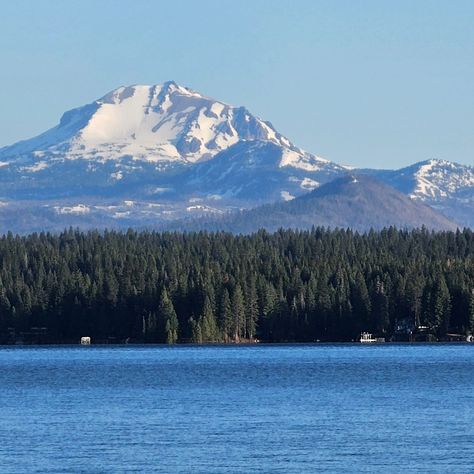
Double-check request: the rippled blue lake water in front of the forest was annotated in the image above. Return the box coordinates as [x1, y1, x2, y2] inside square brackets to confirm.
[0, 344, 474, 474]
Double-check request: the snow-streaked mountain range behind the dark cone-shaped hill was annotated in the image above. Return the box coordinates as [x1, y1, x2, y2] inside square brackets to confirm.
[0, 82, 474, 232]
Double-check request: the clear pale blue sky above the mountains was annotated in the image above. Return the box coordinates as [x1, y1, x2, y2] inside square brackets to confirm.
[0, 0, 474, 168]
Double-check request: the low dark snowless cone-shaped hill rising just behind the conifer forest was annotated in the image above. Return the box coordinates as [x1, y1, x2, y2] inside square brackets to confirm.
[170, 174, 457, 233]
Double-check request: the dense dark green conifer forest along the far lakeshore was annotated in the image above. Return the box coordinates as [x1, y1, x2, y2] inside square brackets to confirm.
[0, 228, 474, 343]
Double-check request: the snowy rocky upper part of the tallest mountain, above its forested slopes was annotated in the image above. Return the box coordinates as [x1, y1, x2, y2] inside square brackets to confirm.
[0, 81, 320, 171]
